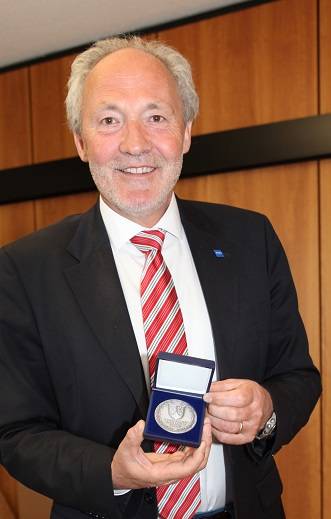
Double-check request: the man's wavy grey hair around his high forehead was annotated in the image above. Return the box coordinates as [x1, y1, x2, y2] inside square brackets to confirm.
[65, 36, 199, 134]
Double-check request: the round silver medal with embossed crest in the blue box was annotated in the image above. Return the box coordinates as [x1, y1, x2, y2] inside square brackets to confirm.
[154, 399, 197, 434]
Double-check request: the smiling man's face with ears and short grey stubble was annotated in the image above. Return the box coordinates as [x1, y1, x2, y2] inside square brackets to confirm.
[75, 49, 191, 227]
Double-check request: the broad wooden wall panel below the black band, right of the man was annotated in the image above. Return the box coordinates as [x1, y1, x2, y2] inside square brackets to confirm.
[176, 163, 321, 519]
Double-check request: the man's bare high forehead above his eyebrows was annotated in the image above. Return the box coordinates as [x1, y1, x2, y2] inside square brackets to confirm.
[84, 49, 181, 109]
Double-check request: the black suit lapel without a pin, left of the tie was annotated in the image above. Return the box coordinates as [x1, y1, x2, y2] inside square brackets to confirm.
[65, 206, 148, 417]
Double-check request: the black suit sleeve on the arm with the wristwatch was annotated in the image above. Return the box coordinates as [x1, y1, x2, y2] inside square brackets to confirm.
[256, 220, 321, 453]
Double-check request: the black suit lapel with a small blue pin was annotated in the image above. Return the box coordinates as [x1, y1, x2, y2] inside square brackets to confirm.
[178, 201, 238, 379]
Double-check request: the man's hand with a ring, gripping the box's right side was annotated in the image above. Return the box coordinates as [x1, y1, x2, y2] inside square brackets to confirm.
[204, 379, 273, 445]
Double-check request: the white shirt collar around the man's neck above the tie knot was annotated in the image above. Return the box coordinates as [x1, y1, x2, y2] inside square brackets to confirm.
[99, 194, 184, 249]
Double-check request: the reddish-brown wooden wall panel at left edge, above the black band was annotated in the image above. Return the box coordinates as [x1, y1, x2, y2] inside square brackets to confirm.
[0, 68, 31, 169]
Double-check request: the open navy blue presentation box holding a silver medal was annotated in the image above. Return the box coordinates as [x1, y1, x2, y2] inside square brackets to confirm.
[144, 352, 215, 447]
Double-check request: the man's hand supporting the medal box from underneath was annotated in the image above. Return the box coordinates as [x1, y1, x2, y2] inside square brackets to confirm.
[111, 418, 212, 489]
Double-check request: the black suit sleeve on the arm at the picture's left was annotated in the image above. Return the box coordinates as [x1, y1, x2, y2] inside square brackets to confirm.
[0, 250, 121, 518]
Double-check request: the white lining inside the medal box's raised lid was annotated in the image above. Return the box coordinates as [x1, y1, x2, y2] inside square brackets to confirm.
[155, 359, 212, 395]
